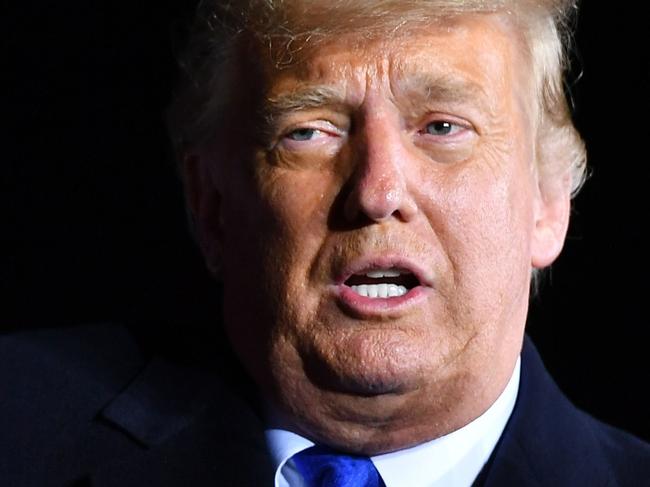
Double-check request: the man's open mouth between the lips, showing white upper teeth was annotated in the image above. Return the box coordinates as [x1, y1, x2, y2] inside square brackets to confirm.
[344, 267, 420, 299]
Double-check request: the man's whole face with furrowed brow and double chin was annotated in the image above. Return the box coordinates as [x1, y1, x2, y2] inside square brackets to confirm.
[195, 15, 565, 453]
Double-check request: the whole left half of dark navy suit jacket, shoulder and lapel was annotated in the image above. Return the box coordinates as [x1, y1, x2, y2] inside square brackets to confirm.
[0, 325, 274, 487]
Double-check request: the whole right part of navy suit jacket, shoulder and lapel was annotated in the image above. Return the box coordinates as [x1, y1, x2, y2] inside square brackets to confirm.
[476, 340, 650, 487]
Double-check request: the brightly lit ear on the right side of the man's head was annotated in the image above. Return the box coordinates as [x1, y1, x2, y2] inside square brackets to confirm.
[531, 173, 571, 269]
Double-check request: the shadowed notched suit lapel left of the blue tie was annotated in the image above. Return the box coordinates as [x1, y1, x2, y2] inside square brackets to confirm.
[91, 359, 273, 487]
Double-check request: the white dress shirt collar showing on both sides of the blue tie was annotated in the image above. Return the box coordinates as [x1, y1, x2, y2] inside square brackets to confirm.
[266, 359, 521, 487]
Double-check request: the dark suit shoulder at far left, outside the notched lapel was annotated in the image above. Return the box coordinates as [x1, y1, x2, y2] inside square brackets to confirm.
[0, 325, 144, 485]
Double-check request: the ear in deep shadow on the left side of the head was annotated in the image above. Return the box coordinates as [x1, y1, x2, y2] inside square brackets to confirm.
[182, 152, 223, 275]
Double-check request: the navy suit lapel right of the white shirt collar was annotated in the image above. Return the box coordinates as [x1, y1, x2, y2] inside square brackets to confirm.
[475, 337, 615, 487]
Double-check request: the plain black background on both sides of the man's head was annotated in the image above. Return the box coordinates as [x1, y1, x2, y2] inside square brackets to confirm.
[0, 0, 650, 440]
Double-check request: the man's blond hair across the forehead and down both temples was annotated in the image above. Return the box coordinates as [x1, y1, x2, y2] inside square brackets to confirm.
[169, 0, 586, 195]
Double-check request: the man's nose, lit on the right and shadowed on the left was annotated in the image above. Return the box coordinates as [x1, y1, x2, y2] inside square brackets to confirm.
[344, 114, 418, 223]
